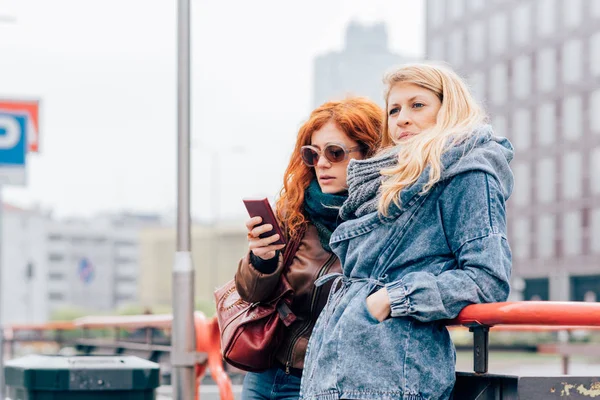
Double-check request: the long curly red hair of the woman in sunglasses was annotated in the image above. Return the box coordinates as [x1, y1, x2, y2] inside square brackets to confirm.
[275, 97, 385, 238]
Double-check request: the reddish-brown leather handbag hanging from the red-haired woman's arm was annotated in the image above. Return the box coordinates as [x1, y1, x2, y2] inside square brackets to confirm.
[214, 225, 304, 372]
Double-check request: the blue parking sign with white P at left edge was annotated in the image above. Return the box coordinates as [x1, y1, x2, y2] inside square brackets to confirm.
[0, 111, 29, 185]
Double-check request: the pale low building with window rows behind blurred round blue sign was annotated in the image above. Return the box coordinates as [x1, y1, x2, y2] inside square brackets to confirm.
[46, 216, 138, 313]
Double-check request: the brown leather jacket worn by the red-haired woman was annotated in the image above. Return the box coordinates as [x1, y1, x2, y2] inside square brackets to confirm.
[235, 224, 342, 372]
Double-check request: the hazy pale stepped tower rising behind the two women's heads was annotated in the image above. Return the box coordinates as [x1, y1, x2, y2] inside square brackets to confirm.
[313, 22, 407, 107]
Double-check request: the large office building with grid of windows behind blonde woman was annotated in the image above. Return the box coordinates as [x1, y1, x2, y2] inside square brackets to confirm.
[426, 0, 600, 300]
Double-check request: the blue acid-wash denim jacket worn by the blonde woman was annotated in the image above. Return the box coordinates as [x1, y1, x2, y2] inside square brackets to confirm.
[301, 126, 513, 400]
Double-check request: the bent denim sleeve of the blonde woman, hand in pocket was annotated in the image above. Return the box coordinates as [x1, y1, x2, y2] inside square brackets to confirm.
[386, 171, 512, 322]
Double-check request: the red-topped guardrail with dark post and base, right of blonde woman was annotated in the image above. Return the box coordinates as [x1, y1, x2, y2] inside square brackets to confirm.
[448, 301, 600, 400]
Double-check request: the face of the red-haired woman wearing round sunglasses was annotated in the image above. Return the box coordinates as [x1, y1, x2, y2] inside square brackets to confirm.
[310, 121, 363, 193]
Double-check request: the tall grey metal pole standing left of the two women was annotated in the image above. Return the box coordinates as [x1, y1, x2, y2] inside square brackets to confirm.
[171, 0, 196, 400]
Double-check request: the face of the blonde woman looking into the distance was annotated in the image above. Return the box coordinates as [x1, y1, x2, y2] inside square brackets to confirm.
[387, 83, 442, 143]
